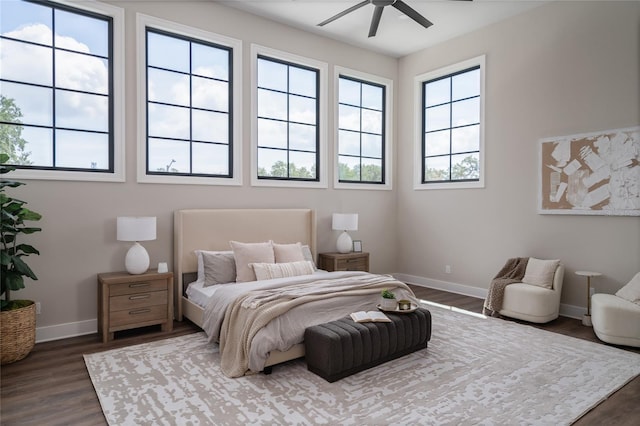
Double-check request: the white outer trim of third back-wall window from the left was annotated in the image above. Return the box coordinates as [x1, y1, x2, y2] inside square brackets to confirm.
[251, 44, 328, 188]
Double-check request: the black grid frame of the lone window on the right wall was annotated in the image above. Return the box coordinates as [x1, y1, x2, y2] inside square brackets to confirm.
[420, 65, 484, 185]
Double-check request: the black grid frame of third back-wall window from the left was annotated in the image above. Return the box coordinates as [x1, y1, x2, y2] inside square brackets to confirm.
[255, 54, 321, 182]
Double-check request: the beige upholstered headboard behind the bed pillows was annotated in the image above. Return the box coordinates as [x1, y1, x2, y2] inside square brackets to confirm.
[173, 209, 316, 320]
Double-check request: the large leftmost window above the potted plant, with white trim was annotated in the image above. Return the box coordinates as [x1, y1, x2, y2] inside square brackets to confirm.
[0, 1, 124, 180]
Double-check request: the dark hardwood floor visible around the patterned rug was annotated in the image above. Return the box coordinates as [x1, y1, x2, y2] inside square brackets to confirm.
[0, 286, 640, 426]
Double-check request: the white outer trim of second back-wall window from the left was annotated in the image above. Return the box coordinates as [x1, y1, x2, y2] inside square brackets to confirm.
[136, 13, 242, 186]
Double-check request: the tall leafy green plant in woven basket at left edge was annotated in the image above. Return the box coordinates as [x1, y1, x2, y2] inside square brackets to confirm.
[0, 153, 42, 364]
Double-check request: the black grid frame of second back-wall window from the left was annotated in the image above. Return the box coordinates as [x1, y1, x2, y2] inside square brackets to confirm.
[144, 26, 235, 179]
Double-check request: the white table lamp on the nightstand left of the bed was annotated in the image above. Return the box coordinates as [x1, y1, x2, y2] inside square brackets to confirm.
[117, 216, 156, 275]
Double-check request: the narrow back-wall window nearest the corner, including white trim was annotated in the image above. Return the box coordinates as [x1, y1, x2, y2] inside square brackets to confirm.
[335, 67, 392, 189]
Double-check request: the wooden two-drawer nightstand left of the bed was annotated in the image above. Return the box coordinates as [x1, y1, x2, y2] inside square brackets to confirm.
[98, 270, 173, 343]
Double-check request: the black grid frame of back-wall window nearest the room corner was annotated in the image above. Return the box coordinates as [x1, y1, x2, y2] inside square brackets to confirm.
[336, 74, 387, 185]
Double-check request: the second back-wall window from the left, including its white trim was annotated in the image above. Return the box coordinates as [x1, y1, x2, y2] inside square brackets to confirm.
[138, 15, 241, 184]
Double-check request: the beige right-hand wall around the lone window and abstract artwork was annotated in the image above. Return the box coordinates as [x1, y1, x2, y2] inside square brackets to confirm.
[397, 2, 640, 307]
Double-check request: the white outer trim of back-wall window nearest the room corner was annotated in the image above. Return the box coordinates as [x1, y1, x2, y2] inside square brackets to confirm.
[333, 66, 394, 190]
